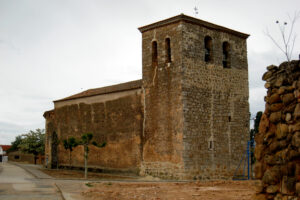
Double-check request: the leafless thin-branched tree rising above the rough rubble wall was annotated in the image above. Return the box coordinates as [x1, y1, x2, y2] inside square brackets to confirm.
[266, 11, 300, 62]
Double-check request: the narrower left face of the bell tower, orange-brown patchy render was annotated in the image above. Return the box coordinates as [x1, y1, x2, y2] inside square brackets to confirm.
[141, 23, 183, 179]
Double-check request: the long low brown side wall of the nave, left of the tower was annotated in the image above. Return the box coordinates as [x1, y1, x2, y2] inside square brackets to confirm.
[46, 91, 143, 173]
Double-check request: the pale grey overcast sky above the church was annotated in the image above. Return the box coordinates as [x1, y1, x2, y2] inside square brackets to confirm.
[0, 0, 300, 144]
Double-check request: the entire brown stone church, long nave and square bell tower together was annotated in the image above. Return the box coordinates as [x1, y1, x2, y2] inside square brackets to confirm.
[44, 14, 249, 179]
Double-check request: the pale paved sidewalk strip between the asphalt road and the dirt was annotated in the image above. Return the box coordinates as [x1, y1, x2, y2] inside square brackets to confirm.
[10, 162, 87, 200]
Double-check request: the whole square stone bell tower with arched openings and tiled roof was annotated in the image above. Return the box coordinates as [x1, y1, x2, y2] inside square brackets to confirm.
[139, 14, 249, 179]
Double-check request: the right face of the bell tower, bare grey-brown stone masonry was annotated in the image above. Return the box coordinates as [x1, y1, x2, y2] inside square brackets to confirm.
[182, 23, 249, 179]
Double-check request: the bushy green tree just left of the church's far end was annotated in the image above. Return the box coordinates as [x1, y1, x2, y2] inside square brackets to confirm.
[15, 129, 45, 156]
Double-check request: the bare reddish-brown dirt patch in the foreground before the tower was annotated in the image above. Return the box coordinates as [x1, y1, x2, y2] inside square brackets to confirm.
[82, 181, 255, 200]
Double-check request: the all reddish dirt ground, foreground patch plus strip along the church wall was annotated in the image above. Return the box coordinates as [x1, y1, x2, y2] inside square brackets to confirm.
[42, 169, 255, 200]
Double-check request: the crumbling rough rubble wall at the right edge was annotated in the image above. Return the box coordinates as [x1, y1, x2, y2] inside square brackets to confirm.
[255, 61, 300, 200]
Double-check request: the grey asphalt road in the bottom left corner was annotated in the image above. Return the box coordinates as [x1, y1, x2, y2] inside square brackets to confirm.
[0, 163, 62, 200]
